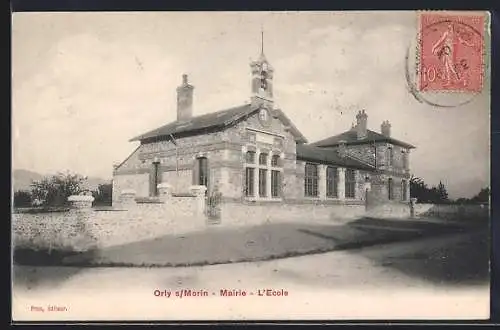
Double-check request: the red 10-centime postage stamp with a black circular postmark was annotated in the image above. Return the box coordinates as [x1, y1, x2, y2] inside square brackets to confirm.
[418, 12, 484, 93]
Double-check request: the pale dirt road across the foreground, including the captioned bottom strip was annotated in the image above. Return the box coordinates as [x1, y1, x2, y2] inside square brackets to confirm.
[13, 228, 489, 320]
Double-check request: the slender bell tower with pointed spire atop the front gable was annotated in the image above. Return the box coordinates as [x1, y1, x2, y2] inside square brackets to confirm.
[250, 31, 274, 108]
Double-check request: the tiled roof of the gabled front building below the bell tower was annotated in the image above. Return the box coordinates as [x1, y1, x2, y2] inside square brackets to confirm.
[130, 104, 307, 143]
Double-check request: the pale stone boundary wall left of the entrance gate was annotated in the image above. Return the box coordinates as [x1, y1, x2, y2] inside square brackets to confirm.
[12, 189, 206, 251]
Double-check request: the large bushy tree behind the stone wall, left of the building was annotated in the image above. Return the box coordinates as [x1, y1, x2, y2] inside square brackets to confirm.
[31, 172, 86, 206]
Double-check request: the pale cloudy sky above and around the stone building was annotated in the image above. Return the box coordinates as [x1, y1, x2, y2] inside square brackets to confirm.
[12, 12, 490, 198]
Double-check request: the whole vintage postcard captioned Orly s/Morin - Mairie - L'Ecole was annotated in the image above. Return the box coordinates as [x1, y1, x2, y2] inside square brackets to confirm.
[11, 11, 490, 322]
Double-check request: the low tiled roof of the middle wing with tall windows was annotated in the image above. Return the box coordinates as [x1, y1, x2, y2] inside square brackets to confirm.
[297, 144, 375, 170]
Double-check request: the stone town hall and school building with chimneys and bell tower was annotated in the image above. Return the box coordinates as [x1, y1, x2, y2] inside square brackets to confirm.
[113, 46, 414, 220]
